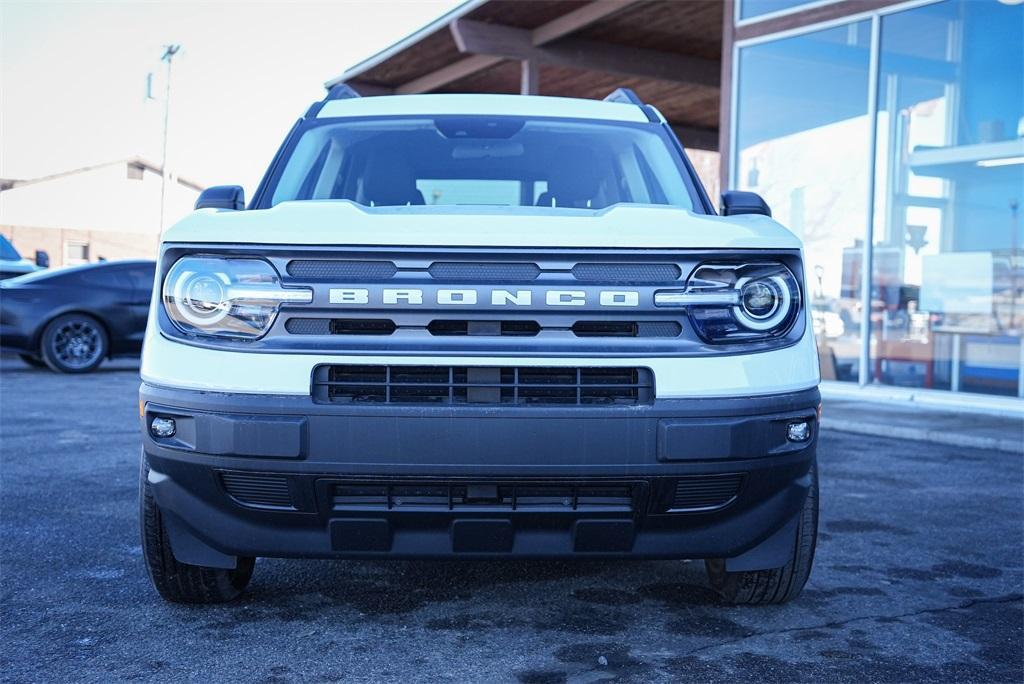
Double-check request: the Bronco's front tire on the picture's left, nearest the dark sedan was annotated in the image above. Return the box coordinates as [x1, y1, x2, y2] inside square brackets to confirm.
[138, 454, 256, 603]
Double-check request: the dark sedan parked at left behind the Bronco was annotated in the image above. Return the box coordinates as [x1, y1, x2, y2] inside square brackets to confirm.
[0, 261, 156, 373]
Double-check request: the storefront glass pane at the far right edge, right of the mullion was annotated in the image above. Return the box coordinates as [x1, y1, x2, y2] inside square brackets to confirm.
[870, 0, 1024, 396]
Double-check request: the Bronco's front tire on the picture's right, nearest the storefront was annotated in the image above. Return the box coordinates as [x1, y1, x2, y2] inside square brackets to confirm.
[705, 464, 818, 605]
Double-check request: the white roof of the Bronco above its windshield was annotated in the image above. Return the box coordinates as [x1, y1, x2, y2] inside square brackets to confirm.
[316, 94, 648, 123]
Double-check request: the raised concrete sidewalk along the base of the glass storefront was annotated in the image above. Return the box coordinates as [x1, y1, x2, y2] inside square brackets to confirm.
[821, 398, 1024, 455]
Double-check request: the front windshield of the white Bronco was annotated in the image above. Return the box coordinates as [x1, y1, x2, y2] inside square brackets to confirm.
[262, 116, 695, 209]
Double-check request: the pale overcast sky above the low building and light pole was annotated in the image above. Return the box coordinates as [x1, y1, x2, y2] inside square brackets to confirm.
[0, 0, 461, 198]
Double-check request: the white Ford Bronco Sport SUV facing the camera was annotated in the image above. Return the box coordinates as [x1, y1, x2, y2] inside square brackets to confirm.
[139, 86, 819, 603]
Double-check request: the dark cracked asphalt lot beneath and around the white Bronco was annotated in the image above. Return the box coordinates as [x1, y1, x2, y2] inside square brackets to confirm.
[0, 357, 1024, 683]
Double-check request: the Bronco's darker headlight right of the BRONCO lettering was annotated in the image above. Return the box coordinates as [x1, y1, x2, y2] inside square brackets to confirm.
[654, 262, 800, 342]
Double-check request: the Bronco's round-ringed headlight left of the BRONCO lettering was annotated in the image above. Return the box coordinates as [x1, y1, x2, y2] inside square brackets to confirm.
[164, 257, 313, 340]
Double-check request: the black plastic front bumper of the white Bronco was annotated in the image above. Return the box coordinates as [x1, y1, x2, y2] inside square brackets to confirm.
[141, 384, 819, 569]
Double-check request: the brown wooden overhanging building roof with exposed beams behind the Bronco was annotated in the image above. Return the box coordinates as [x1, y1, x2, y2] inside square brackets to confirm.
[327, 0, 720, 149]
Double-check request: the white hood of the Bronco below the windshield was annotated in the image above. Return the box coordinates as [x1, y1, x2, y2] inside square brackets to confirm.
[164, 201, 801, 249]
